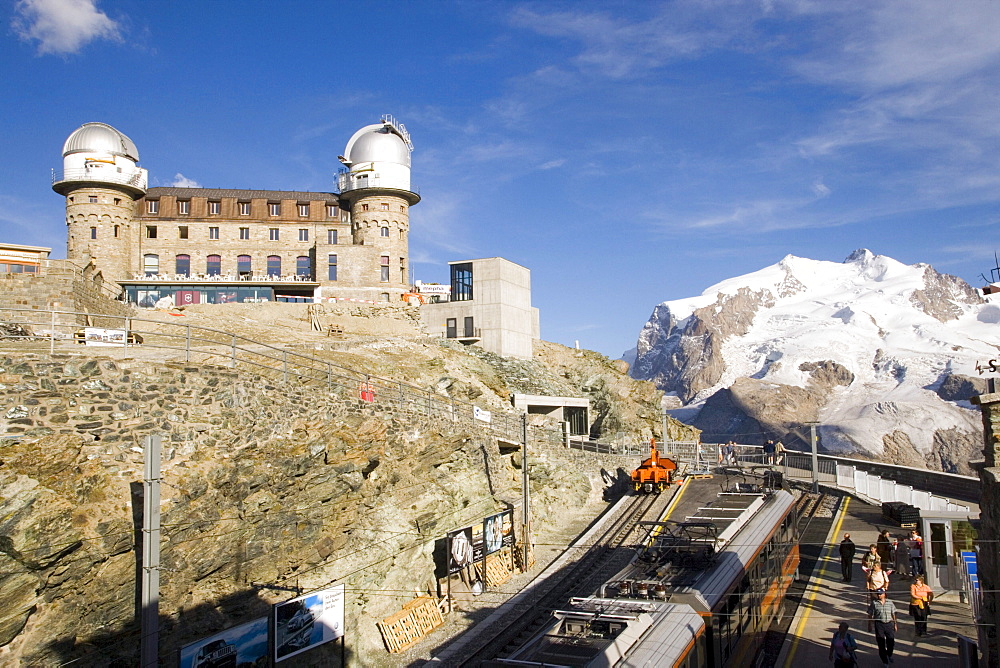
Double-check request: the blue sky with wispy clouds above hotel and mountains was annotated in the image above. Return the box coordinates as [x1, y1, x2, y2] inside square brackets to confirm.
[0, 0, 1000, 357]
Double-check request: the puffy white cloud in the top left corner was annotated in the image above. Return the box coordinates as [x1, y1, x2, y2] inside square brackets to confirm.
[12, 0, 121, 54]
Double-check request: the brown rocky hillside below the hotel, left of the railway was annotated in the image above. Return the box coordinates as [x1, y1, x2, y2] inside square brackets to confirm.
[0, 305, 690, 666]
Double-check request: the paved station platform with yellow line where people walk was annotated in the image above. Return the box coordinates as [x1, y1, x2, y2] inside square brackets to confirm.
[775, 497, 976, 668]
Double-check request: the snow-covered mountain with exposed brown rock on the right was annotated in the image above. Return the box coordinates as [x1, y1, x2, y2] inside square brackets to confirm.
[630, 250, 1000, 472]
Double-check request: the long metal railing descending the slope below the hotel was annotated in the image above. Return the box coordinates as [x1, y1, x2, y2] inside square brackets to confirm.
[0, 308, 521, 443]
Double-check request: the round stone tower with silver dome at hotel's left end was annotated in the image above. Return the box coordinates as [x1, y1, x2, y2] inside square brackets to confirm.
[52, 123, 147, 281]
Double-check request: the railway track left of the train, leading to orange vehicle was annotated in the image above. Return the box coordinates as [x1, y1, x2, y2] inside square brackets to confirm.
[445, 494, 673, 668]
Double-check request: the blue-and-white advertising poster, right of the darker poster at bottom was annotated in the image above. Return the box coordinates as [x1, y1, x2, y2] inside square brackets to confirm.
[274, 585, 344, 662]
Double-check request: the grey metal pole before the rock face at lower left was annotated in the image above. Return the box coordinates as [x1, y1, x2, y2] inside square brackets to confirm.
[139, 434, 161, 668]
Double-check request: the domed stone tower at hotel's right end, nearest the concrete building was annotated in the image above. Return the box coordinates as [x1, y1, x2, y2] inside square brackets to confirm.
[338, 116, 420, 301]
